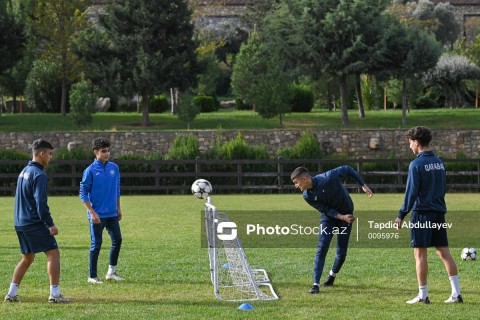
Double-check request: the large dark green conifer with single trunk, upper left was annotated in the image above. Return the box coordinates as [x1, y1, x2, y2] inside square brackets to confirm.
[77, 0, 197, 127]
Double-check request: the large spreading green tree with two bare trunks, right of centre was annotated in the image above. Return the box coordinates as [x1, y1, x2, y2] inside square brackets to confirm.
[265, 0, 394, 125]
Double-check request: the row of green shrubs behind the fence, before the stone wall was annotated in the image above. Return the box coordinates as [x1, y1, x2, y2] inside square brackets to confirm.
[0, 132, 477, 192]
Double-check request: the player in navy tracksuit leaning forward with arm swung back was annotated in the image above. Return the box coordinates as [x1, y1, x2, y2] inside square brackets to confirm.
[290, 165, 373, 293]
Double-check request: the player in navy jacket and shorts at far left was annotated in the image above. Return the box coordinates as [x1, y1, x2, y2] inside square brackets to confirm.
[4, 139, 69, 303]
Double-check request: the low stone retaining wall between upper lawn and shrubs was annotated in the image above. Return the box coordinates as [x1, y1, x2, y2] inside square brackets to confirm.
[0, 129, 480, 158]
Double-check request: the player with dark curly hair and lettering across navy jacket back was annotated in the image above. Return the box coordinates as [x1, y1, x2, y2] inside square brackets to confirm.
[395, 126, 463, 304]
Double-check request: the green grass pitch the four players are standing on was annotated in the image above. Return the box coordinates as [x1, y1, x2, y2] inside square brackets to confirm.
[0, 194, 480, 319]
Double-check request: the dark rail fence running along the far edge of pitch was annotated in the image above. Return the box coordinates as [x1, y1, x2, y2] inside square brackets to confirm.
[0, 158, 480, 195]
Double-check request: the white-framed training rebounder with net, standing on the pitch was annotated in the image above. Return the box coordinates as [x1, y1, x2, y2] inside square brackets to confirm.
[205, 197, 278, 301]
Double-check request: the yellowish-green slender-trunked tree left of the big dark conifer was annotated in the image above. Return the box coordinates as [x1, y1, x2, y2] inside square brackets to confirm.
[29, 0, 90, 116]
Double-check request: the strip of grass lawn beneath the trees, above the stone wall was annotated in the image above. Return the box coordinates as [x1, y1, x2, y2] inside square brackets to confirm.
[0, 108, 480, 132]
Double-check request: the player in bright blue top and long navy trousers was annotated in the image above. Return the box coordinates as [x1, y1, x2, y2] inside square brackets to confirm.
[80, 138, 123, 284]
